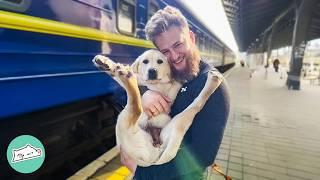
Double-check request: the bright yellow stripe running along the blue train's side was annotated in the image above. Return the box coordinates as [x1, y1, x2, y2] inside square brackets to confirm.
[0, 10, 154, 48]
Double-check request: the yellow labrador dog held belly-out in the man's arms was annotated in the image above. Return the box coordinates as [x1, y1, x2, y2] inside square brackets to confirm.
[93, 50, 222, 166]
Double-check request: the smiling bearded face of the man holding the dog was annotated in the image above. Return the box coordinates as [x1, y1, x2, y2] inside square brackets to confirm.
[155, 26, 200, 80]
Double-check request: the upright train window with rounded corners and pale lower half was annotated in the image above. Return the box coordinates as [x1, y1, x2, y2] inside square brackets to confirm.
[117, 0, 136, 35]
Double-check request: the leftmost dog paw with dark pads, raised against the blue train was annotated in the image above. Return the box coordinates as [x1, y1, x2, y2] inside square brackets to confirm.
[92, 55, 115, 76]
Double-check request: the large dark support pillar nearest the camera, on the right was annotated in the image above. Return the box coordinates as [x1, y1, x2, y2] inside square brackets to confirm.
[286, 0, 317, 90]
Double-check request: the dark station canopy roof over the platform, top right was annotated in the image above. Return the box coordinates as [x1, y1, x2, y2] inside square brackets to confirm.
[222, 0, 320, 52]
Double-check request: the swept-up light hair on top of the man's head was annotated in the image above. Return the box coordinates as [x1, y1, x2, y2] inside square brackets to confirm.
[145, 6, 189, 43]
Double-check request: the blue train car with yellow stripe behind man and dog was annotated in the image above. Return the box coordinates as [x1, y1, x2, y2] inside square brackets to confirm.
[0, 0, 235, 179]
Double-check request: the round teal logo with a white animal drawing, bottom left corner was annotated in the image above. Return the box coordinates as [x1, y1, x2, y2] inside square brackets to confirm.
[7, 135, 45, 174]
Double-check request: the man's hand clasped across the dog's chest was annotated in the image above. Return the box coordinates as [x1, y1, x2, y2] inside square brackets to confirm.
[142, 90, 172, 117]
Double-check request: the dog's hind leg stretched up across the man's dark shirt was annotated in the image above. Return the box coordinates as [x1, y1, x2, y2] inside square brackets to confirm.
[156, 71, 223, 164]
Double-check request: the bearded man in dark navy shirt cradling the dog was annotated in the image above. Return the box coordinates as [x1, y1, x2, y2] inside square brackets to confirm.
[121, 6, 229, 180]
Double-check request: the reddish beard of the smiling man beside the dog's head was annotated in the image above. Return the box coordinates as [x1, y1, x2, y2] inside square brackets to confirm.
[170, 49, 200, 83]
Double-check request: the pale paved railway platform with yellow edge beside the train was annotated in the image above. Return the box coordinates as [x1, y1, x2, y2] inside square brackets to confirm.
[70, 67, 320, 180]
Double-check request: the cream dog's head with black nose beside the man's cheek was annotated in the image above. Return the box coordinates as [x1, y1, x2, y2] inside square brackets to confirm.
[131, 49, 171, 85]
